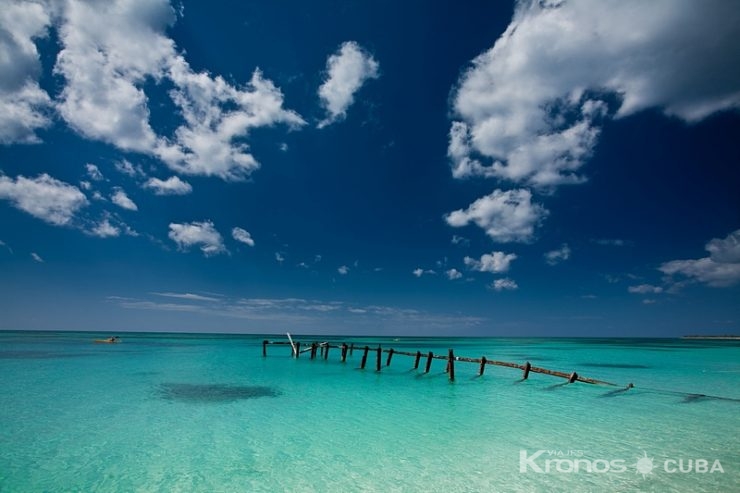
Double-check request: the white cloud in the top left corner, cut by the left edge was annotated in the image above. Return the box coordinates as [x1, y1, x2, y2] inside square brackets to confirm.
[0, 1, 52, 144]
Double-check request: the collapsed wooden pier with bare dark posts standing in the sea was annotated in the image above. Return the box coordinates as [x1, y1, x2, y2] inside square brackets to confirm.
[262, 335, 617, 386]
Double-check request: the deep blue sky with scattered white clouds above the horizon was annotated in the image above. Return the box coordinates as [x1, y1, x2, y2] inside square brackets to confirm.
[0, 0, 740, 336]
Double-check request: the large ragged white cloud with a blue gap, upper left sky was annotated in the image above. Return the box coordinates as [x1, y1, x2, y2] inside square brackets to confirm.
[49, 0, 305, 180]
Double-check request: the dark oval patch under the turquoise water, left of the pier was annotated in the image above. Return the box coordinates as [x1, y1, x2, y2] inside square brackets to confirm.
[159, 383, 280, 403]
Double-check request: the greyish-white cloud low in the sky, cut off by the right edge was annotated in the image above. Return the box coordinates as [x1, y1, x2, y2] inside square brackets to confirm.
[659, 229, 740, 288]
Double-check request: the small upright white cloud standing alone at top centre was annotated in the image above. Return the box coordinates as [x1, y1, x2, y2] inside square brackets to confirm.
[318, 41, 379, 128]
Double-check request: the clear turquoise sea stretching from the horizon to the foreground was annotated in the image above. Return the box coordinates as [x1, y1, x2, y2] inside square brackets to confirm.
[0, 332, 740, 493]
